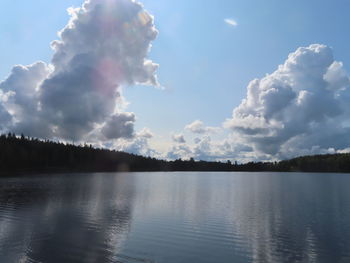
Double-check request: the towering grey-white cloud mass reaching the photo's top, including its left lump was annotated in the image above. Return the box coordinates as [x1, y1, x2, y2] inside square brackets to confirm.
[0, 0, 158, 140]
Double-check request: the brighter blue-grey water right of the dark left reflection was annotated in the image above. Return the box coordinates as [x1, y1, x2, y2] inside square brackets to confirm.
[126, 173, 350, 263]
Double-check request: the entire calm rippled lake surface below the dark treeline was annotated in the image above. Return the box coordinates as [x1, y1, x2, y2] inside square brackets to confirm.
[0, 173, 350, 263]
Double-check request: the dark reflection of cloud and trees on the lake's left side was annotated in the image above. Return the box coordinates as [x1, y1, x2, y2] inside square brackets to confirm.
[0, 175, 134, 263]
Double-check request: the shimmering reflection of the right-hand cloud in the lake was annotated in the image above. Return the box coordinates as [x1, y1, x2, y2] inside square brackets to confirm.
[228, 174, 350, 262]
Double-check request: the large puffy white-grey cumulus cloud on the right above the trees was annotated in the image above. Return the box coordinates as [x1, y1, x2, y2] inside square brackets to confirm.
[225, 44, 350, 158]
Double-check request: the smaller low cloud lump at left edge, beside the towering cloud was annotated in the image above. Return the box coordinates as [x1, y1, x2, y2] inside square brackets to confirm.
[0, 62, 51, 138]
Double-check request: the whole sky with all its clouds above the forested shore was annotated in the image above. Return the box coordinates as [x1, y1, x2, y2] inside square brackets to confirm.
[0, 0, 350, 162]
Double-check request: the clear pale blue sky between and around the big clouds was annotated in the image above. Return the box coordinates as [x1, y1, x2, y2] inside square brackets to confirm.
[0, 0, 350, 162]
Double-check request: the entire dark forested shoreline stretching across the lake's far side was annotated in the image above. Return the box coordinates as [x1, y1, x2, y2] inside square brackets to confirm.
[0, 133, 350, 175]
